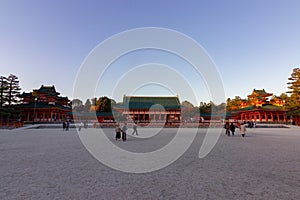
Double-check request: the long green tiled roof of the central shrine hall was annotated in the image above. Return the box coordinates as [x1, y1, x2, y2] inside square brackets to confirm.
[121, 96, 180, 109]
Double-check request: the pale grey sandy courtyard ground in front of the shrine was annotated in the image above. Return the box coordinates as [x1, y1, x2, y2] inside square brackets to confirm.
[0, 128, 300, 200]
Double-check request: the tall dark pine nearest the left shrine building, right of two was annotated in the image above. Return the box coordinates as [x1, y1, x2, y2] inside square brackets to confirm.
[7, 74, 21, 109]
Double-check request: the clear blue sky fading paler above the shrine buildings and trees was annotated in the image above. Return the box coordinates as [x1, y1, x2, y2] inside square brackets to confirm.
[0, 0, 300, 105]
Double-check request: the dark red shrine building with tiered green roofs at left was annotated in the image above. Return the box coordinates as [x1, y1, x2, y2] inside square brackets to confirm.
[18, 85, 72, 122]
